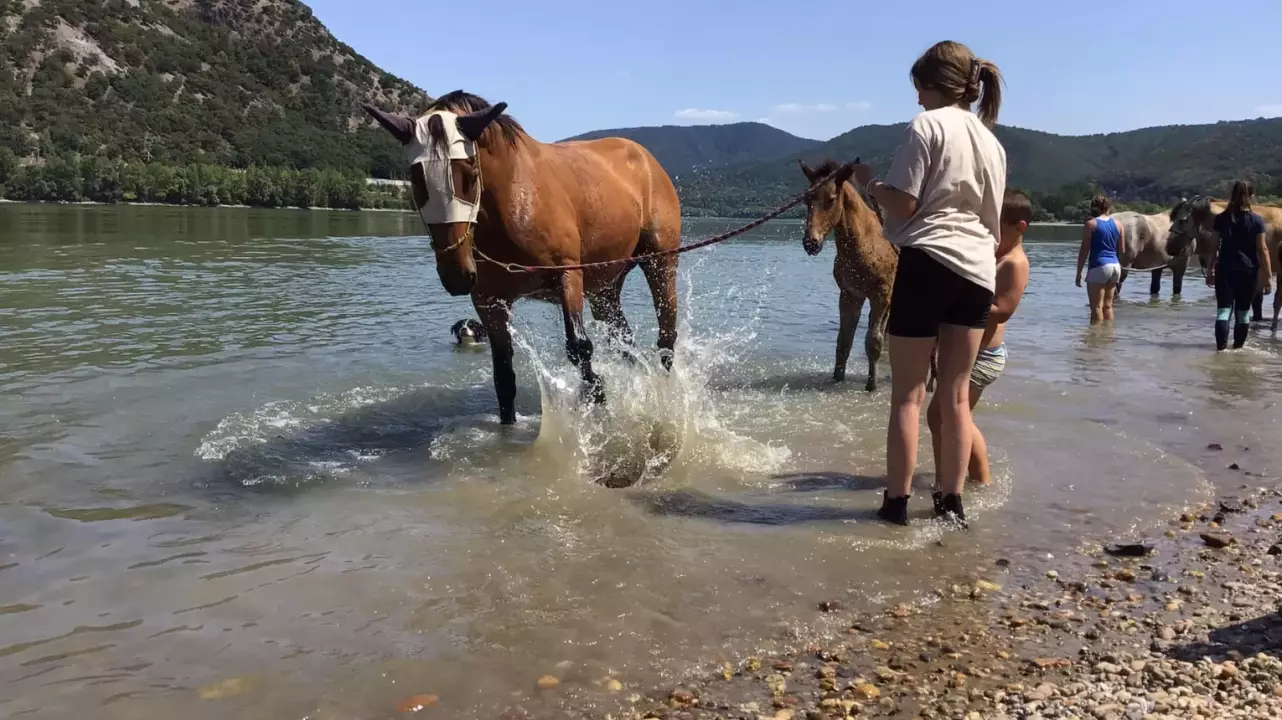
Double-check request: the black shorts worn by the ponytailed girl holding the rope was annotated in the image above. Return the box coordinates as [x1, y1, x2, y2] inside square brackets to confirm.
[886, 247, 992, 337]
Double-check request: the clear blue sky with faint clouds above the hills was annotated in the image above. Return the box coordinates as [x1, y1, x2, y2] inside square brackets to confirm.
[304, 0, 1282, 141]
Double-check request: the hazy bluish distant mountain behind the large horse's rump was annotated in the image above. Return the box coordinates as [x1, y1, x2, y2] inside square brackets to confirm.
[569, 123, 822, 177]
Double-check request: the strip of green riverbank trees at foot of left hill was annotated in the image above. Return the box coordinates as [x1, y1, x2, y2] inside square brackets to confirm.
[0, 147, 409, 210]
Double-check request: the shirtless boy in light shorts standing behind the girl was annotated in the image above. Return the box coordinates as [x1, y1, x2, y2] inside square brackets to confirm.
[926, 190, 1033, 484]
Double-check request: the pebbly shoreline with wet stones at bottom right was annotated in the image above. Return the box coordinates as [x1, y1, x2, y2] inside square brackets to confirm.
[504, 452, 1282, 720]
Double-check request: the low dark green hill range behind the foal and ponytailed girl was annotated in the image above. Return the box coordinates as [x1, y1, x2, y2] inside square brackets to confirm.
[595, 119, 1282, 217]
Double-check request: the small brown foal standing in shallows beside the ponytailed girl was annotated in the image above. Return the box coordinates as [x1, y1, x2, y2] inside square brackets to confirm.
[801, 160, 899, 392]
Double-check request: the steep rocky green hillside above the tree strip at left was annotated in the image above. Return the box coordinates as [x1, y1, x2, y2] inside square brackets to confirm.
[0, 0, 428, 204]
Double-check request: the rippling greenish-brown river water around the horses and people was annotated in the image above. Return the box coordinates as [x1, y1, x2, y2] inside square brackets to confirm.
[0, 205, 1282, 720]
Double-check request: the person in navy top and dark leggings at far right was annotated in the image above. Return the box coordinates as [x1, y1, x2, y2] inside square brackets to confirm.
[1206, 181, 1273, 350]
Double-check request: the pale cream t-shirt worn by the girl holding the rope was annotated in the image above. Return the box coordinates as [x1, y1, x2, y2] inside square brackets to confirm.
[886, 108, 1006, 290]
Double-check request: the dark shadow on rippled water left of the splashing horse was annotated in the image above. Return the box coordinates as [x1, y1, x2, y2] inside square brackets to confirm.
[197, 386, 525, 493]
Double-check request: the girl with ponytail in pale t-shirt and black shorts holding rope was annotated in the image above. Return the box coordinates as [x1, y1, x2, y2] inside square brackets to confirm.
[855, 41, 1006, 527]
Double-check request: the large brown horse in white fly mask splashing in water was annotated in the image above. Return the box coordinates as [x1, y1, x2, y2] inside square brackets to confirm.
[364, 90, 681, 424]
